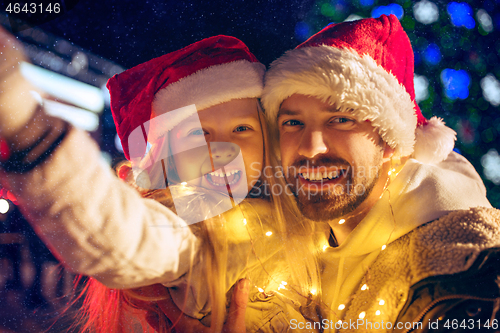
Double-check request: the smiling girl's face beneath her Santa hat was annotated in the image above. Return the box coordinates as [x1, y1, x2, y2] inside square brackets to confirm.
[168, 98, 264, 197]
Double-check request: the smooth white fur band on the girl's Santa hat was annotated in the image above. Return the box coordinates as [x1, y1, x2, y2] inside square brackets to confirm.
[152, 60, 265, 119]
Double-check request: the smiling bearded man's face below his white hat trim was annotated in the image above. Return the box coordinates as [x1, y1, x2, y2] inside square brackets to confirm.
[278, 94, 390, 221]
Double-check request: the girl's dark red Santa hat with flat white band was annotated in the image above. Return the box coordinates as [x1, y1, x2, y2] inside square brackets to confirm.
[106, 36, 265, 159]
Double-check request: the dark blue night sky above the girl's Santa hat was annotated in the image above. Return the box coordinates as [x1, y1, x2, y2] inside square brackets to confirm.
[34, 0, 314, 68]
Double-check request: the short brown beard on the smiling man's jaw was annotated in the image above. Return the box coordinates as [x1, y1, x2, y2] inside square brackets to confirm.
[287, 158, 382, 222]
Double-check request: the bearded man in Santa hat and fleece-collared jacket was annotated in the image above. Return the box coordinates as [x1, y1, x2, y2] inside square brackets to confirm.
[262, 15, 500, 331]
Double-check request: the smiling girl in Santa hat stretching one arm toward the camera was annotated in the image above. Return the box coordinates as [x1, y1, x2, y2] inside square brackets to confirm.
[0, 30, 318, 332]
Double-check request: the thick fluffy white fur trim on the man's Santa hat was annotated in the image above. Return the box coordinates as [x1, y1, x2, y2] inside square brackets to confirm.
[262, 45, 417, 156]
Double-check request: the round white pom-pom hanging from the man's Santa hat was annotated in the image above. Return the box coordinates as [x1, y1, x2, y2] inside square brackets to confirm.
[413, 117, 457, 164]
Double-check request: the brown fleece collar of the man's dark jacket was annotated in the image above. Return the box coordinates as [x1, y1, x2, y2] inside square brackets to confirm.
[341, 208, 500, 332]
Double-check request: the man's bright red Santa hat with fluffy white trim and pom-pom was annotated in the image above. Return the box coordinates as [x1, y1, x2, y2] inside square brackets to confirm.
[262, 15, 456, 163]
